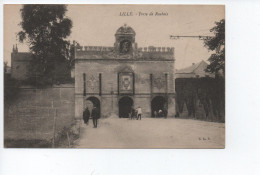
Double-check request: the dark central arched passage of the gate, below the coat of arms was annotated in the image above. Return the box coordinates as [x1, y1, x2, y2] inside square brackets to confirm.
[118, 97, 134, 118]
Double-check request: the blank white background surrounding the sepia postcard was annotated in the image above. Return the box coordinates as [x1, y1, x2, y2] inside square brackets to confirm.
[0, 0, 260, 175]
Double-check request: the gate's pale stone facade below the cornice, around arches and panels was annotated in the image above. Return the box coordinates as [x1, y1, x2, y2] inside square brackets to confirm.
[75, 59, 175, 118]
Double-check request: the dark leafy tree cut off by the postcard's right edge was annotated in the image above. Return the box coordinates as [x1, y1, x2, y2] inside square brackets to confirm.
[204, 19, 225, 74]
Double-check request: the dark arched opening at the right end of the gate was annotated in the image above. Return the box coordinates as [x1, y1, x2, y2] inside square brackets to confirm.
[151, 96, 168, 117]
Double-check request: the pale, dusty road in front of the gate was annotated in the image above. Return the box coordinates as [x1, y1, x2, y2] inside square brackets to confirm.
[75, 118, 225, 148]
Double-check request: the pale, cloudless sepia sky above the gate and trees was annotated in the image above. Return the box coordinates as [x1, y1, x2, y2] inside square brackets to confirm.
[4, 4, 225, 69]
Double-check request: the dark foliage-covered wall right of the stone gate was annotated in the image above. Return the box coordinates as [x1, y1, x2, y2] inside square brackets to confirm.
[175, 77, 225, 121]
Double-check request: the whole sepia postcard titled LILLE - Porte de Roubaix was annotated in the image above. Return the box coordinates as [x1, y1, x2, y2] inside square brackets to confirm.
[3, 4, 226, 149]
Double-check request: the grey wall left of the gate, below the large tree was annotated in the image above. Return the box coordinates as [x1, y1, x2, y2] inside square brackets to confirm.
[4, 84, 75, 140]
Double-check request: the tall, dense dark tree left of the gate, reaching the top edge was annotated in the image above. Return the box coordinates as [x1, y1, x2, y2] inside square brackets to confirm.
[18, 5, 72, 84]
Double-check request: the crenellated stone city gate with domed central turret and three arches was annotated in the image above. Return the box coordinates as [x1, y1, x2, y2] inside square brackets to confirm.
[75, 25, 175, 119]
